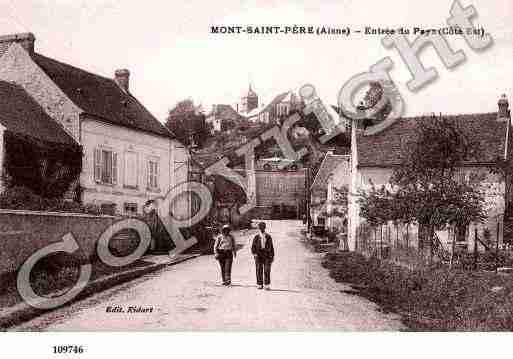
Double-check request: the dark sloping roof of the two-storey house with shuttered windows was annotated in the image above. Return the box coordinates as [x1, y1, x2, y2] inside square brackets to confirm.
[33, 54, 174, 138]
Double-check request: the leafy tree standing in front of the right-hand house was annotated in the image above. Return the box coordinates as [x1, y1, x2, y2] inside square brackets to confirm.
[359, 117, 486, 259]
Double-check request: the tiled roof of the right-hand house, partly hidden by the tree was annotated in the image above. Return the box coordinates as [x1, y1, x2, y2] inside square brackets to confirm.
[357, 113, 508, 167]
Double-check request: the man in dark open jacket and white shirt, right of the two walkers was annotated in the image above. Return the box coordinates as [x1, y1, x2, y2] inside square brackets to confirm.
[251, 222, 274, 290]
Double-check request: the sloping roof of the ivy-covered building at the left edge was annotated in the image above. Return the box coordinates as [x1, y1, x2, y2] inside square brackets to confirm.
[0, 81, 75, 144]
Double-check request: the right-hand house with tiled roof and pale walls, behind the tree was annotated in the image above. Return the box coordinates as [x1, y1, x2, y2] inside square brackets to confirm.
[348, 97, 511, 250]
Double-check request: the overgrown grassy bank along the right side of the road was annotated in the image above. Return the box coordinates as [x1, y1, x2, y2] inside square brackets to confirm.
[323, 253, 513, 331]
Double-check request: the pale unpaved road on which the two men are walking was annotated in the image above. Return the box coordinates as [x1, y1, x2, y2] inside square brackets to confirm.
[14, 221, 403, 331]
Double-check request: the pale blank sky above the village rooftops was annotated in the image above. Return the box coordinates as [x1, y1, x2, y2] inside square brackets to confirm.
[0, 0, 513, 121]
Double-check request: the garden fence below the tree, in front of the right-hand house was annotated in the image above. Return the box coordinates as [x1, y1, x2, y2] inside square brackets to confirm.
[355, 217, 513, 270]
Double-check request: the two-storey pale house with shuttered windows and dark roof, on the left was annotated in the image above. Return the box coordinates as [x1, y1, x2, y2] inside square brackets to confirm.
[0, 33, 190, 215]
